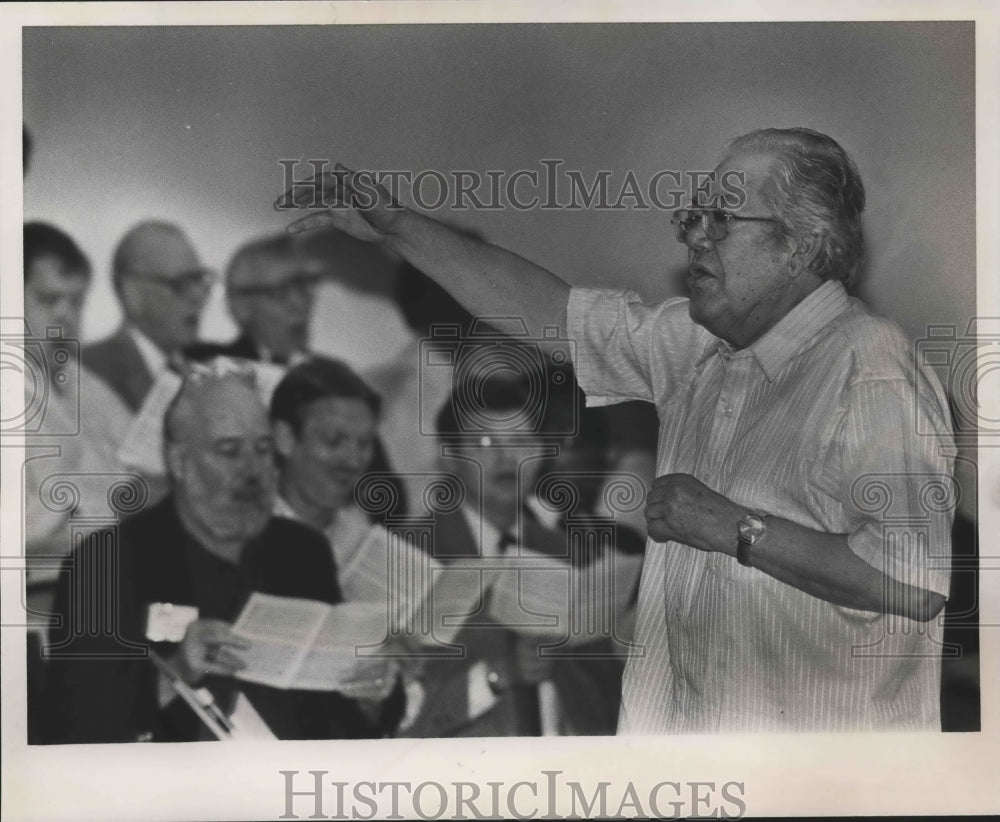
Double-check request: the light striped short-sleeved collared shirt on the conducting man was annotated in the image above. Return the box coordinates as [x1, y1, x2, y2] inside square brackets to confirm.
[569, 282, 955, 734]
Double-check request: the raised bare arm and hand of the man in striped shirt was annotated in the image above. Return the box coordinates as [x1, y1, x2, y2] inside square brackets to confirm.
[275, 164, 570, 336]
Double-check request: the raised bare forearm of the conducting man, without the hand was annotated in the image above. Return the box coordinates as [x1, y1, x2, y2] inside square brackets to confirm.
[385, 209, 570, 336]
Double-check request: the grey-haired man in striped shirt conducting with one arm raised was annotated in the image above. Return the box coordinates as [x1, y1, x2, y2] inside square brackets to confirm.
[277, 129, 953, 733]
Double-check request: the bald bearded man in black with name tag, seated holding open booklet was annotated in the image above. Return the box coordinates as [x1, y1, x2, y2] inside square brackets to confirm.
[46, 361, 394, 742]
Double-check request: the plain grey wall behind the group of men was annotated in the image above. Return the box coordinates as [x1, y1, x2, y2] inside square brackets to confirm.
[23, 22, 976, 350]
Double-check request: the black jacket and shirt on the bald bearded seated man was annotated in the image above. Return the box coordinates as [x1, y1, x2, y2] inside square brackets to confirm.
[43, 497, 382, 743]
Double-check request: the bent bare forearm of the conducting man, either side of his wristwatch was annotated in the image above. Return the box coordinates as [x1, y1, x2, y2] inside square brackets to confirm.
[697, 500, 944, 622]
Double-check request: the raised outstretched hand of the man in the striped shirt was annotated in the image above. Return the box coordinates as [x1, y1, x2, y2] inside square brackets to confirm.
[274, 163, 404, 242]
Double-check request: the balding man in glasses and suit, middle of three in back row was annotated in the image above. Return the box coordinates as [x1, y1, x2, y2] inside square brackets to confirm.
[83, 222, 215, 412]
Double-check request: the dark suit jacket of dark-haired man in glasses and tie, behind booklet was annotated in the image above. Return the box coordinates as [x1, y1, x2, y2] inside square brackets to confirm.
[401, 511, 623, 737]
